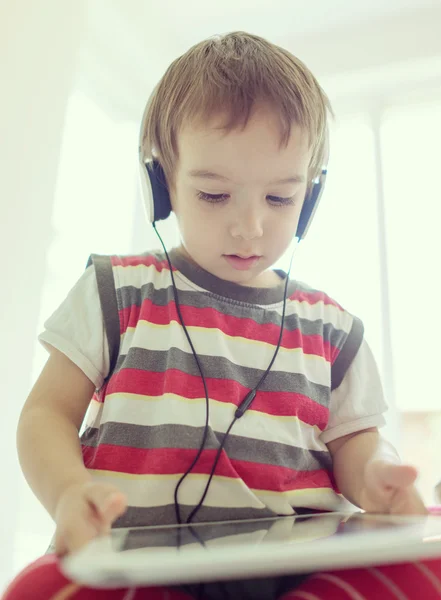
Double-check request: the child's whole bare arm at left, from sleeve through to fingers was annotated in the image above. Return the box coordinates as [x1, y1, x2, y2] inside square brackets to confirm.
[17, 349, 126, 553]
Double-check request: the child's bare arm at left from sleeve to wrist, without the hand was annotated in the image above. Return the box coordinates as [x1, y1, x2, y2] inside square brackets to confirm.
[17, 349, 94, 517]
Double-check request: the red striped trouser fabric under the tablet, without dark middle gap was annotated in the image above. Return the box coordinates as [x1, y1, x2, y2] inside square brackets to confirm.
[2, 554, 441, 600]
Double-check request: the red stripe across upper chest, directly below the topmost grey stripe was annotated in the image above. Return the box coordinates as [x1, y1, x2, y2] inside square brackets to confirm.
[119, 299, 339, 362]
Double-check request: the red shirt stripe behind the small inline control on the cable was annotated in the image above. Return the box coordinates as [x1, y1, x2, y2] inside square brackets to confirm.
[106, 369, 329, 431]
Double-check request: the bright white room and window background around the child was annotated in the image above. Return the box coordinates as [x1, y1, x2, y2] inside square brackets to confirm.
[0, 0, 441, 589]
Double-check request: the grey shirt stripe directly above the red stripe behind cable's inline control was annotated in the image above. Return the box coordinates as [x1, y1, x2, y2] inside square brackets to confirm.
[116, 346, 330, 407]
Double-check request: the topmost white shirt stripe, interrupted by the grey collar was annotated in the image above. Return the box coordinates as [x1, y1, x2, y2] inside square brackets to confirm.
[114, 265, 352, 332]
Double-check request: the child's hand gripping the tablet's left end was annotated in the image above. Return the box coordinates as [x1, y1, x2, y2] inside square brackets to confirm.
[55, 482, 127, 554]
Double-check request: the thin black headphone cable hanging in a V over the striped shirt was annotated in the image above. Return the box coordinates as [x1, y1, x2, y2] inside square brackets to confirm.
[152, 222, 295, 525]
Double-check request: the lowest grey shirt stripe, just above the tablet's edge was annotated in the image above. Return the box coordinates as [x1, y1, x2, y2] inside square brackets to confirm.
[113, 504, 278, 527]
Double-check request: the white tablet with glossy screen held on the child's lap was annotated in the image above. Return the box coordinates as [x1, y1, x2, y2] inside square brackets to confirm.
[62, 513, 441, 588]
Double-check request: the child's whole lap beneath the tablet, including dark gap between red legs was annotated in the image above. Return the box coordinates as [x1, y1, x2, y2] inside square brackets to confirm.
[3, 555, 441, 600]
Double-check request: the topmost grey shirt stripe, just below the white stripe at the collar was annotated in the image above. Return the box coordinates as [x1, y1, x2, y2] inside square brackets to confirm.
[116, 283, 347, 349]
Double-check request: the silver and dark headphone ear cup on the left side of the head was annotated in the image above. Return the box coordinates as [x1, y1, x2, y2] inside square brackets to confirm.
[139, 160, 172, 223]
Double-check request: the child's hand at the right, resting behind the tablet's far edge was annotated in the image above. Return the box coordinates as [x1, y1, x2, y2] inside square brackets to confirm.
[360, 459, 427, 515]
